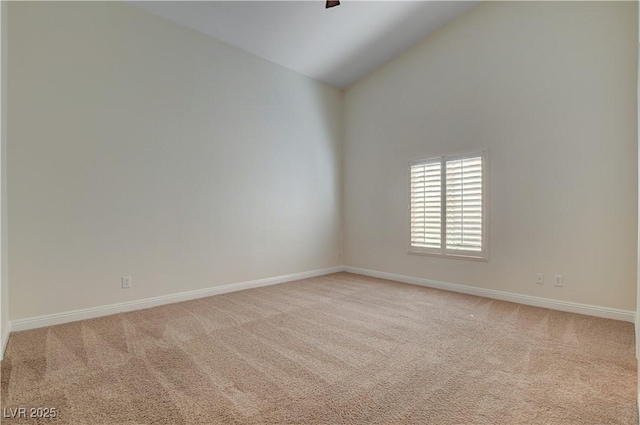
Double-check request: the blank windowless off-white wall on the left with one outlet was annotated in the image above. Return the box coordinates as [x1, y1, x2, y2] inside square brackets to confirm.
[8, 2, 342, 320]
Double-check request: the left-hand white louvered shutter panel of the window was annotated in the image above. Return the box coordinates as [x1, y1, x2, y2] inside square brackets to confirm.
[410, 158, 442, 253]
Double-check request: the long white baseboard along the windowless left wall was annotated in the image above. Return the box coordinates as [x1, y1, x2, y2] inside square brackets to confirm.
[10, 266, 344, 332]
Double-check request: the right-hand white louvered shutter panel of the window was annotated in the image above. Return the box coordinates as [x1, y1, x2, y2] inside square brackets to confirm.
[446, 154, 484, 253]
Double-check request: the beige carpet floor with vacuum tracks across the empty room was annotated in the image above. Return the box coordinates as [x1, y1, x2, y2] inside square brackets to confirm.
[1, 273, 638, 425]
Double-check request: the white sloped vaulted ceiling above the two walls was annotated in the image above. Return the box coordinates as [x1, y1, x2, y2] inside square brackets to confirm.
[133, 0, 479, 88]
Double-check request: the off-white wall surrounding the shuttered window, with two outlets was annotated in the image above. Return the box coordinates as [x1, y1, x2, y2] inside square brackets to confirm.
[344, 2, 638, 311]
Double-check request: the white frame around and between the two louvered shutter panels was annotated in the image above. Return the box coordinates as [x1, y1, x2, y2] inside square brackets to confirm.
[407, 148, 489, 262]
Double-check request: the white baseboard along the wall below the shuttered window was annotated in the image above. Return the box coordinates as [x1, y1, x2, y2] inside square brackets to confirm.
[344, 266, 635, 323]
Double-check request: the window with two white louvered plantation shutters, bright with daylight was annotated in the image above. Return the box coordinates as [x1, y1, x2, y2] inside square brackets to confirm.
[409, 150, 488, 260]
